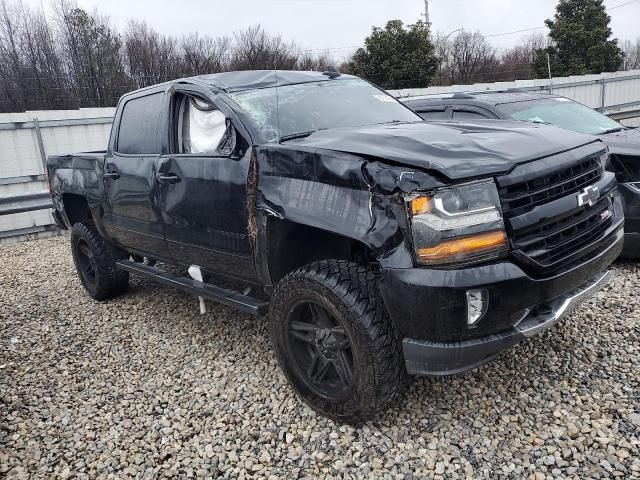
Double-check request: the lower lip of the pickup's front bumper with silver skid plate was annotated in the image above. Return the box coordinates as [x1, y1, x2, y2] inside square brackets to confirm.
[402, 271, 610, 375]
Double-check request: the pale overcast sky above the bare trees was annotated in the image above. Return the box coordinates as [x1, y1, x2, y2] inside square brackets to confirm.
[38, 0, 640, 56]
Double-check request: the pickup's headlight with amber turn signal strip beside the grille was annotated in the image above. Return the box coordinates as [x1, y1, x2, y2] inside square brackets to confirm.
[407, 180, 507, 265]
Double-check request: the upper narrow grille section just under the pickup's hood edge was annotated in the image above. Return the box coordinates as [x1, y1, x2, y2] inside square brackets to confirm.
[500, 158, 604, 216]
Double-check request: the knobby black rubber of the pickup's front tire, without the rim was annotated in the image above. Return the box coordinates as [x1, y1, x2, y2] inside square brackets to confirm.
[270, 260, 408, 424]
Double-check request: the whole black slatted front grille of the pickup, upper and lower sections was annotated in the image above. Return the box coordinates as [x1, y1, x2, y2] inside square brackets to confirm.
[499, 157, 613, 275]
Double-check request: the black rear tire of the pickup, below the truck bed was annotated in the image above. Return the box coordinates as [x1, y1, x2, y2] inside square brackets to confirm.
[71, 220, 129, 300]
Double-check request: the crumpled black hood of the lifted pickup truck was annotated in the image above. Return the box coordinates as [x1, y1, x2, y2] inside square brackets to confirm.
[298, 120, 604, 179]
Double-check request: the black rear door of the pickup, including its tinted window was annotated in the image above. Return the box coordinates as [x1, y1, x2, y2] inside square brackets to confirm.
[104, 89, 170, 259]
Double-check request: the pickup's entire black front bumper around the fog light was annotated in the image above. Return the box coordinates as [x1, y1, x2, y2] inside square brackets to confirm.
[380, 221, 624, 375]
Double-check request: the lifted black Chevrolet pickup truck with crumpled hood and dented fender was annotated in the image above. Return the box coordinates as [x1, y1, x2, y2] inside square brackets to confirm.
[48, 71, 623, 422]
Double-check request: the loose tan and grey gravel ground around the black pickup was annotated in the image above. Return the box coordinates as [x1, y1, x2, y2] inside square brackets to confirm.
[0, 237, 640, 479]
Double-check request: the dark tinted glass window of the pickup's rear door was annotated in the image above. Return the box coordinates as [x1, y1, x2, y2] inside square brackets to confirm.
[117, 92, 164, 154]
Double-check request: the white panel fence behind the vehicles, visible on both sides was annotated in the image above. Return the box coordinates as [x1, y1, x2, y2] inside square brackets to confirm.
[0, 70, 640, 243]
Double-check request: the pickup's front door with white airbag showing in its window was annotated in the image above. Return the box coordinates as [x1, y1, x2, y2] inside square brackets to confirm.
[157, 95, 255, 281]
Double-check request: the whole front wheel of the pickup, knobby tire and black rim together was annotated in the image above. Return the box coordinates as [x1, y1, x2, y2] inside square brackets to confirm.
[270, 260, 407, 423]
